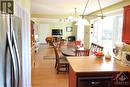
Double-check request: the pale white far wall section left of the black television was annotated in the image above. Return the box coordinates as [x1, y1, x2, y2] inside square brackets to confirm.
[38, 24, 51, 43]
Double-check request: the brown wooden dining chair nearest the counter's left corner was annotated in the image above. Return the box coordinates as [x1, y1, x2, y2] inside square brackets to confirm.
[54, 46, 69, 74]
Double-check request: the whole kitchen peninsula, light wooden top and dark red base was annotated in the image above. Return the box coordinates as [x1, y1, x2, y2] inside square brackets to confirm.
[67, 56, 130, 87]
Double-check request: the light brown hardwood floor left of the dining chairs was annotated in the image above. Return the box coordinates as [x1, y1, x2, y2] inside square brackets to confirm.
[32, 45, 68, 87]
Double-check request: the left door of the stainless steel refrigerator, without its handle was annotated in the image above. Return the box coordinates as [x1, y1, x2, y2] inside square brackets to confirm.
[0, 14, 10, 87]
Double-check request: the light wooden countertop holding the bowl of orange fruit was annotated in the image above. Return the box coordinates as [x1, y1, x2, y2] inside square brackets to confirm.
[67, 56, 130, 73]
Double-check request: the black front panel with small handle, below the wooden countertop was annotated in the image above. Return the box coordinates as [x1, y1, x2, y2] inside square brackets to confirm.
[78, 76, 112, 87]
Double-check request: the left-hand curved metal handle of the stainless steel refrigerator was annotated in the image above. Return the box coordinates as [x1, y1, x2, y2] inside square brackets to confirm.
[7, 32, 18, 87]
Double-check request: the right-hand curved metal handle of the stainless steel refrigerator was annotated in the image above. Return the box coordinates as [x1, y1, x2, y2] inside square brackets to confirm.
[12, 31, 20, 87]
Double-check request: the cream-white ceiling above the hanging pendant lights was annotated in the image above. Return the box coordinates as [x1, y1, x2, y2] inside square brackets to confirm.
[31, 0, 122, 22]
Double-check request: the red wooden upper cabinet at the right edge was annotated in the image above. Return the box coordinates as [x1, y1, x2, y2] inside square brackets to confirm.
[122, 5, 130, 44]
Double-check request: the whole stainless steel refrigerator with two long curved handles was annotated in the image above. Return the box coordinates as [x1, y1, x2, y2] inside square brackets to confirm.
[0, 14, 22, 87]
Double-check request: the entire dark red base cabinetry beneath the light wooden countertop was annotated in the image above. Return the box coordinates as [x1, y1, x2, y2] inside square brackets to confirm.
[69, 66, 130, 87]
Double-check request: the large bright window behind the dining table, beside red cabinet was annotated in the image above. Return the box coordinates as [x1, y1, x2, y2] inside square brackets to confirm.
[91, 16, 123, 52]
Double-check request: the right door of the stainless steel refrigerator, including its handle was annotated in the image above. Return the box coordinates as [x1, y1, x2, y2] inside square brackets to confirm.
[11, 16, 22, 86]
